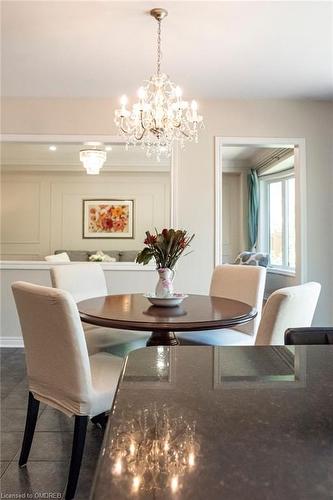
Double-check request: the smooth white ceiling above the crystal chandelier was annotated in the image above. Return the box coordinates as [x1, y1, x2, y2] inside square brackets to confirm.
[1, 0, 333, 99]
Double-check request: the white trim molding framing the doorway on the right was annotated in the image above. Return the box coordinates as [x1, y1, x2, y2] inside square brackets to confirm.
[215, 137, 307, 283]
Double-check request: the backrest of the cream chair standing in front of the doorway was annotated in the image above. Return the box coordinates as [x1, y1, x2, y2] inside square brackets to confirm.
[209, 264, 266, 335]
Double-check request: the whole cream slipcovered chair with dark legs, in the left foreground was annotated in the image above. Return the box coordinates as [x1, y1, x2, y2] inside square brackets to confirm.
[12, 282, 123, 500]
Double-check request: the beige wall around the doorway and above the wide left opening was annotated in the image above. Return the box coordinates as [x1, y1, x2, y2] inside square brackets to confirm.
[2, 99, 333, 324]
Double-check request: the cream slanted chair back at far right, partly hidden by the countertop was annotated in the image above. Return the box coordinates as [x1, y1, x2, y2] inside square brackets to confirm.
[256, 282, 321, 345]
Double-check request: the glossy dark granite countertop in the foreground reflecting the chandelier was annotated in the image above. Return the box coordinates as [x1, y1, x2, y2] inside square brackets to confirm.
[91, 346, 333, 500]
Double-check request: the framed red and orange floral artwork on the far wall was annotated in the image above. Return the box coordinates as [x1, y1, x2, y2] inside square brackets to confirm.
[83, 199, 134, 238]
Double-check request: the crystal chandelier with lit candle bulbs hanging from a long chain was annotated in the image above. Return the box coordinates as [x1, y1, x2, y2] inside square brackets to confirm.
[115, 8, 203, 160]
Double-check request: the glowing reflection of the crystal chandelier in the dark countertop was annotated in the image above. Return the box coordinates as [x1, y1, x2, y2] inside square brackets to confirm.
[110, 407, 199, 493]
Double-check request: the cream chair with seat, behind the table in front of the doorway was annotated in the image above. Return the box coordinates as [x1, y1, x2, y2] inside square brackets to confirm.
[178, 264, 266, 345]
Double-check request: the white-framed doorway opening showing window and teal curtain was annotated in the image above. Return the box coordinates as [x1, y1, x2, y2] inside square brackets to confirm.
[215, 137, 306, 291]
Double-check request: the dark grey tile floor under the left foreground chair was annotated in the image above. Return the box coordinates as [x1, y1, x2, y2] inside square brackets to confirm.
[0, 349, 113, 500]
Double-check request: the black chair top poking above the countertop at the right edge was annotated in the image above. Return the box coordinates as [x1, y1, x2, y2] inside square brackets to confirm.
[284, 326, 333, 345]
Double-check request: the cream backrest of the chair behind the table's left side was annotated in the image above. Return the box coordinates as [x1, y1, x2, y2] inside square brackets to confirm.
[50, 262, 108, 302]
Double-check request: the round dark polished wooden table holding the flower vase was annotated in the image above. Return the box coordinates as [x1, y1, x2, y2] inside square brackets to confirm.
[78, 293, 257, 346]
